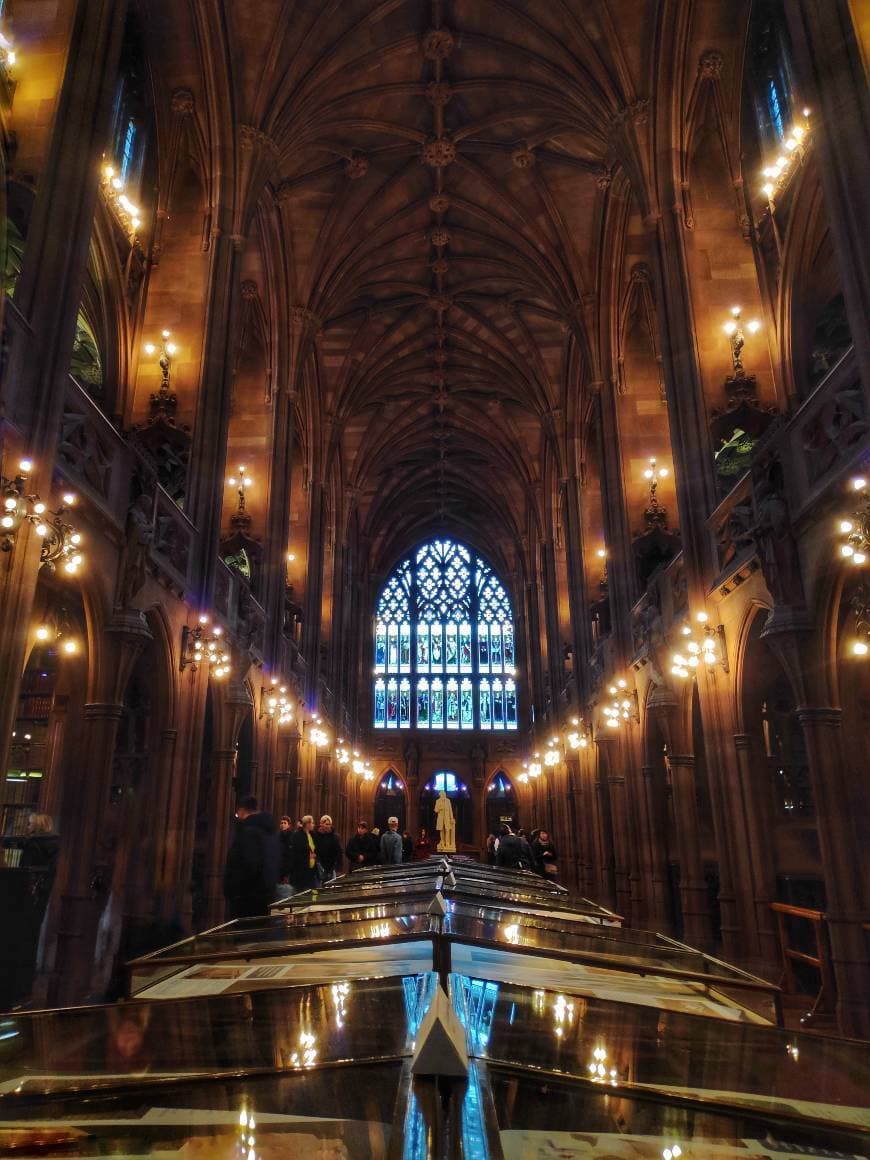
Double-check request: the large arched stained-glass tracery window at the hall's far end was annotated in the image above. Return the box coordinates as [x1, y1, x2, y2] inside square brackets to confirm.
[374, 539, 517, 730]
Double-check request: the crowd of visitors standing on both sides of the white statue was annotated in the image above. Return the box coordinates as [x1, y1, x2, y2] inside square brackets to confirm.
[224, 797, 559, 919]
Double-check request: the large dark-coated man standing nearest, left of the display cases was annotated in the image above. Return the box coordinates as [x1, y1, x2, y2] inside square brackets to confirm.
[224, 797, 281, 919]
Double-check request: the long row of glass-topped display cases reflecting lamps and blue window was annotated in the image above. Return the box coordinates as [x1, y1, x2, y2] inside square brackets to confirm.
[0, 860, 870, 1160]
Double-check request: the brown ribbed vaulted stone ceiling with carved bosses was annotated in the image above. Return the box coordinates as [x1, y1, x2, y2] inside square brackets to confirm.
[177, 0, 650, 575]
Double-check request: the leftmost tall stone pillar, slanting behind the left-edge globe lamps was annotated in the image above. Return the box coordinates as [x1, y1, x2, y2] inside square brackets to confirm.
[0, 0, 126, 788]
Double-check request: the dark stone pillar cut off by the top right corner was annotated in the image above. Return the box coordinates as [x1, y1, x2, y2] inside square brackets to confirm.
[784, 0, 870, 399]
